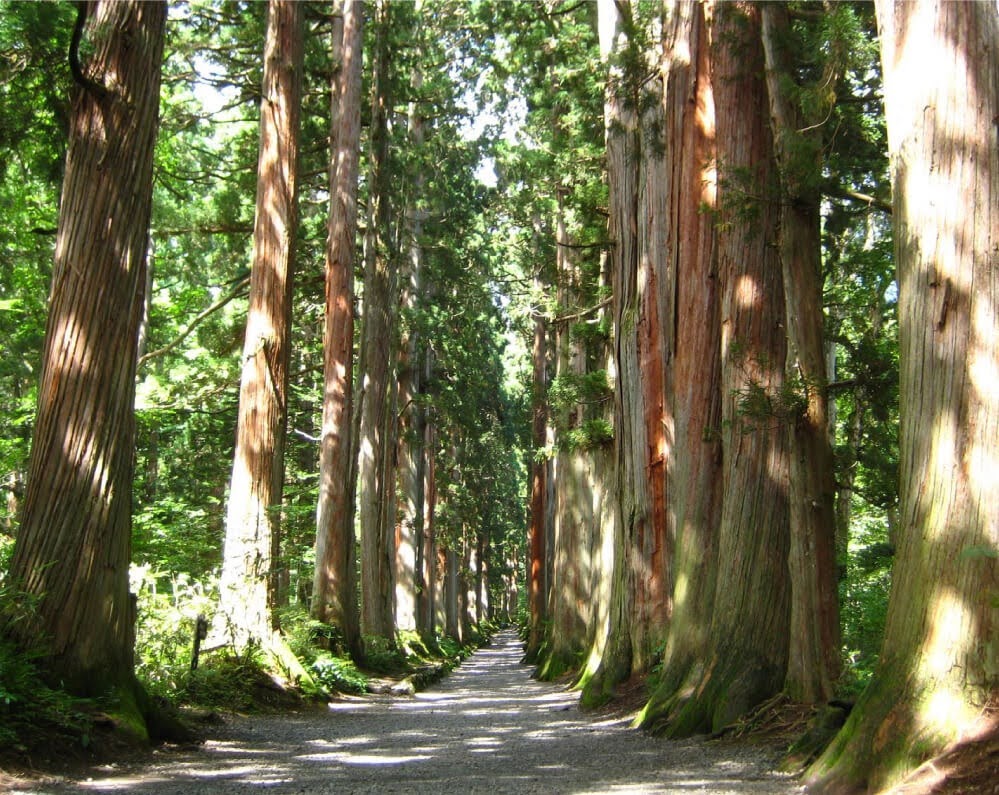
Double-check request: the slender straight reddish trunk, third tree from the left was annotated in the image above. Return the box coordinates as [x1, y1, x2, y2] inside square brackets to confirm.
[312, 0, 364, 654]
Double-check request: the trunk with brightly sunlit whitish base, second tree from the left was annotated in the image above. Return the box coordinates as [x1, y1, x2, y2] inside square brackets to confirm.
[214, 0, 303, 651]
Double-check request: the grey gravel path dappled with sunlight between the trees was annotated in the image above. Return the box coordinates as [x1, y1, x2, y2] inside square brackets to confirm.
[20, 632, 801, 795]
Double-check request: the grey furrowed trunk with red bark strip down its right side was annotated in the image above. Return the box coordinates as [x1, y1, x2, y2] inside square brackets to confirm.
[586, 2, 671, 698]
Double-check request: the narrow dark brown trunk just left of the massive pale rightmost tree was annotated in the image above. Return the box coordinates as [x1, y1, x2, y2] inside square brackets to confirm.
[760, 3, 841, 704]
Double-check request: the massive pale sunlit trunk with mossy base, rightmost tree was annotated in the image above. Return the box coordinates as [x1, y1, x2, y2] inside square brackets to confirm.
[809, 0, 999, 792]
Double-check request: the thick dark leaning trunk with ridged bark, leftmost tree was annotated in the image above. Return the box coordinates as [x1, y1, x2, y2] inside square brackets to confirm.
[11, 0, 166, 703]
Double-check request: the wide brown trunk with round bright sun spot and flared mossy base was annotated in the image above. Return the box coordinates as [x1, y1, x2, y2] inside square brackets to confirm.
[660, 3, 790, 736]
